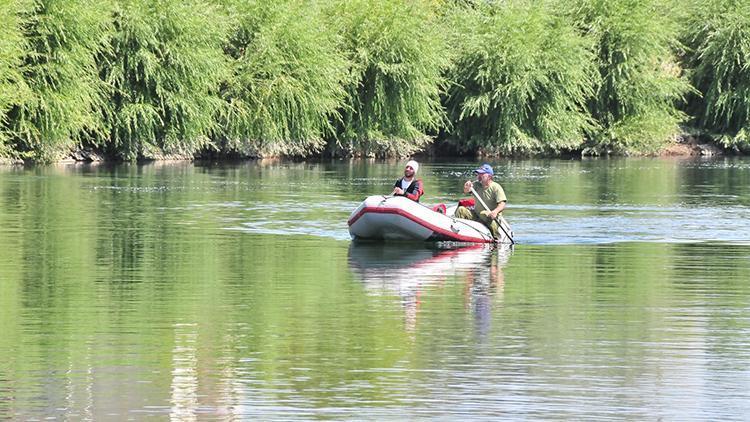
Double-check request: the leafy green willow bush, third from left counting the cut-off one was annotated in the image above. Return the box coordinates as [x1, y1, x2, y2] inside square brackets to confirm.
[102, 0, 227, 160]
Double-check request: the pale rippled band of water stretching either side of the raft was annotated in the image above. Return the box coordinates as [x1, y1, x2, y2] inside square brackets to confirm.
[198, 198, 750, 245]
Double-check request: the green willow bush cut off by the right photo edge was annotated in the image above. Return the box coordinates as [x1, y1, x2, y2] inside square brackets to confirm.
[684, 0, 750, 151]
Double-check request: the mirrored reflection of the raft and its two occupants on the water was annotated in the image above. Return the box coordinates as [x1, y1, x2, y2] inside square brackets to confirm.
[348, 243, 512, 335]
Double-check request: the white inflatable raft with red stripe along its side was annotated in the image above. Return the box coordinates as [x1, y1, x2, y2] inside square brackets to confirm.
[348, 195, 513, 243]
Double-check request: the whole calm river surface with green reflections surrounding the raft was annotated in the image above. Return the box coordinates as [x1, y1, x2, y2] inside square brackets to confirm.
[0, 159, 750, 420]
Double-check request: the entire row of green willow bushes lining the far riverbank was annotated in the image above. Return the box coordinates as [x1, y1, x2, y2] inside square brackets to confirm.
[0, 0, 750, 161]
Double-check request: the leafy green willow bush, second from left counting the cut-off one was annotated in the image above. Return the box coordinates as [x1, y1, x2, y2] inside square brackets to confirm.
[9, 0, 108, 161]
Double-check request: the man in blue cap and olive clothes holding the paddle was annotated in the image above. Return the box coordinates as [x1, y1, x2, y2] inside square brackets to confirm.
[455, 163, 508, 239]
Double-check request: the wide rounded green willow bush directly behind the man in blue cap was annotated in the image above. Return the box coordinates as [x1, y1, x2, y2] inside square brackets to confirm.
[446, 1, 598, 154]
